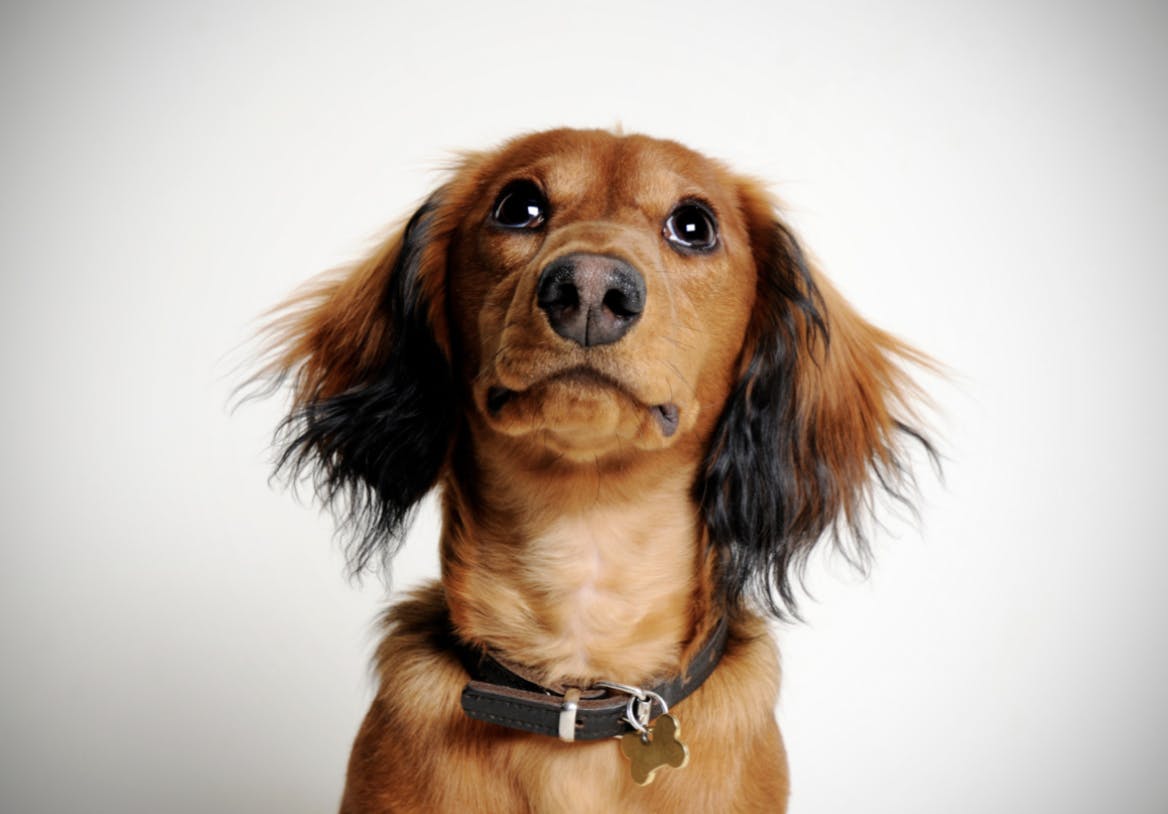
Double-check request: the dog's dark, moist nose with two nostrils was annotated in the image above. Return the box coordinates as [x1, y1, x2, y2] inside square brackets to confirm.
[536, 253, 645, 347]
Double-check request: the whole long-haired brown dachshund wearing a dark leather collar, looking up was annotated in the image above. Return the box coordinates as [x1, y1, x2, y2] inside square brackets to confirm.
[265, 130, 931, 814]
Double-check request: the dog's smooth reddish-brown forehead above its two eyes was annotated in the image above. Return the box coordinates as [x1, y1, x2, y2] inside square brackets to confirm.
[471, 131, 732, 209]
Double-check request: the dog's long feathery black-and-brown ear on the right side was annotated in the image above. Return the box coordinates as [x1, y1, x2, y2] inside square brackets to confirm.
[698, 183, 936, 618]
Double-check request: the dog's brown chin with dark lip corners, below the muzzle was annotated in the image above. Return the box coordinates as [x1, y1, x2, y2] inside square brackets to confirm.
[480, 376, 682, 461]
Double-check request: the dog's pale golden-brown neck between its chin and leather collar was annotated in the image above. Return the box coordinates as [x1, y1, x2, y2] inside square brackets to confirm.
[443, 432, 714, 686]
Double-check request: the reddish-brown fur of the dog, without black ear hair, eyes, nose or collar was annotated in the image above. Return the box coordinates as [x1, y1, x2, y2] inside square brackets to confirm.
[262, 131, 923, 814]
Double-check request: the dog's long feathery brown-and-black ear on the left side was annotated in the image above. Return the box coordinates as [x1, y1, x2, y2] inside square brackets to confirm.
[265, 190, 456, 575]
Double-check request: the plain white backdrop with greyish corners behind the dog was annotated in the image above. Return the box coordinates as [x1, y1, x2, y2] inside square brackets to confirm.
[0, 1, 1168, 814]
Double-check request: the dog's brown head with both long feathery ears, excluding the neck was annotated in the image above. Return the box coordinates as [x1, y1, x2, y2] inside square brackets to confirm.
[262, 130, 929, 613]
